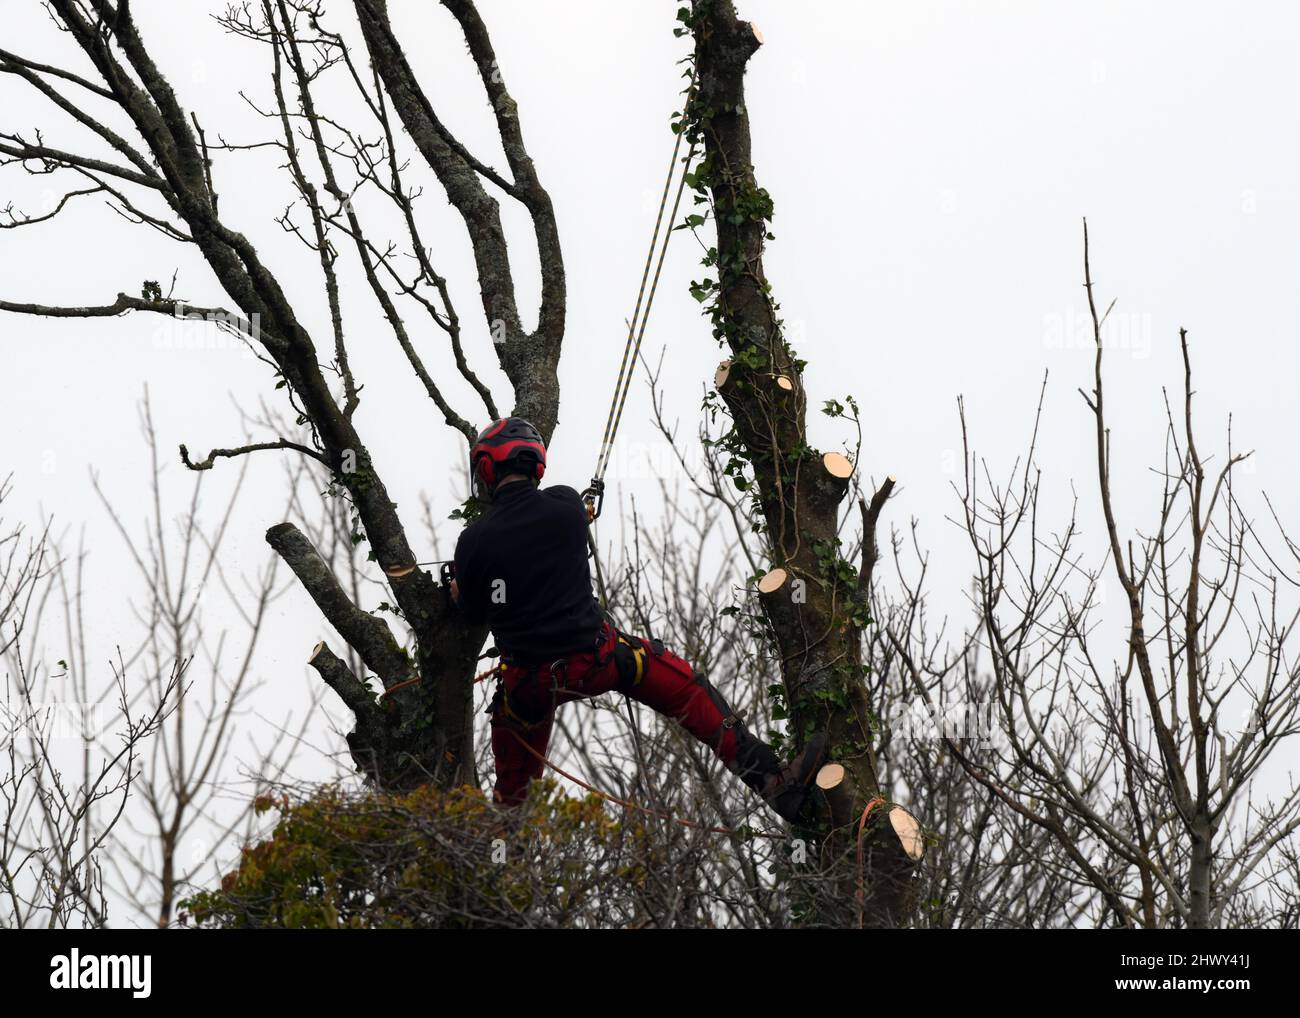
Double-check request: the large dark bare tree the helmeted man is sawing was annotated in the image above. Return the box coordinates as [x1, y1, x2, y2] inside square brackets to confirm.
[0, 0, 564, 784]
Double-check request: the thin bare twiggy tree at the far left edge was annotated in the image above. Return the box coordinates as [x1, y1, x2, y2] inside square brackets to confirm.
[0, 481, 182, 928]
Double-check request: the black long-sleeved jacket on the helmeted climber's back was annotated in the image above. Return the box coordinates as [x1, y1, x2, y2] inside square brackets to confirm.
[456, 481, 602, 663]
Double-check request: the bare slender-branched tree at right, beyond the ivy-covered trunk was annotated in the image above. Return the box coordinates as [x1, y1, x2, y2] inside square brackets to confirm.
[914, 228, 1300, 928]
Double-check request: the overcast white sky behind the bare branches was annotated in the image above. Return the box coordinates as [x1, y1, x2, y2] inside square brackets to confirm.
[0, 0, 1300, 868]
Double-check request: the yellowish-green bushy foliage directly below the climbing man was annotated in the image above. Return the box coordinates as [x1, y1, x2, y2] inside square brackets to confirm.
[182, 781, 645, 930]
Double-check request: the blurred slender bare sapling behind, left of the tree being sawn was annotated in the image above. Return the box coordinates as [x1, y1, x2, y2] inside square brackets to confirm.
[94, 395, 316, 926]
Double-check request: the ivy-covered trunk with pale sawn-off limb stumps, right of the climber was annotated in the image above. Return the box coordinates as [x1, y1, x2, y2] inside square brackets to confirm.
[686, 0, 914, 926]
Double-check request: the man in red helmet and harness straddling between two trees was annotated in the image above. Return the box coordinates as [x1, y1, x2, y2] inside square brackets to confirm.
[451, 417, 826, 822]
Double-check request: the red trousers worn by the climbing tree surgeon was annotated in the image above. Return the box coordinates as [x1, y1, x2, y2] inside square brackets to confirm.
[491, 627, 738, 803]
